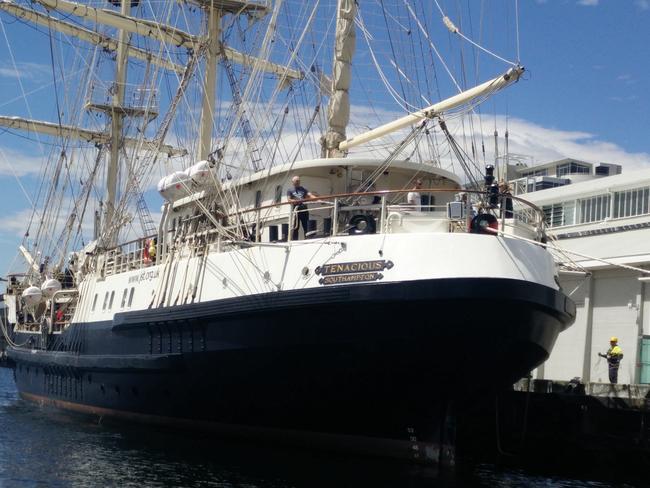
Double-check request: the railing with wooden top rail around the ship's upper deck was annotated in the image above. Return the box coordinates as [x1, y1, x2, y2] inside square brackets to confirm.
[99, 188, 545, 276]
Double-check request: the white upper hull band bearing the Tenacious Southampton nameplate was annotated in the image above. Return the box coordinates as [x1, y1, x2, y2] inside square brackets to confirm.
[73, 233, 558, 322]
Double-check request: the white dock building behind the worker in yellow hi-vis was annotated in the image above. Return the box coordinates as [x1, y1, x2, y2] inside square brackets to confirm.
[508, 158, 650, 384]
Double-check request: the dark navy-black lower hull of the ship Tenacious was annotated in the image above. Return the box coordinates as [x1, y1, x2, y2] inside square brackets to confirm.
[8, 278, 575, 460]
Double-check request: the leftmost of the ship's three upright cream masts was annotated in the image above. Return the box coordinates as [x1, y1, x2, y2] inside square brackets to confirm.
[105, 0, 131, 230]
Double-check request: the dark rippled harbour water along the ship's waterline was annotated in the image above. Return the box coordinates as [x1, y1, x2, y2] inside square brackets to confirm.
[0, 368, 647, 488]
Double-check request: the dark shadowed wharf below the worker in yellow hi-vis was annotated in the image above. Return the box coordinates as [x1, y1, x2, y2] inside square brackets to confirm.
[457, 378, 650, 469]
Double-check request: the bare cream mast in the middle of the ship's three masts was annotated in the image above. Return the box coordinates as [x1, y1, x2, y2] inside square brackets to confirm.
[199, 4, 222, 160]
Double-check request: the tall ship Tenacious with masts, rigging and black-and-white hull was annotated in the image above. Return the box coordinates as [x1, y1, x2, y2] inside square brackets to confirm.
[0, 0, 575, 463]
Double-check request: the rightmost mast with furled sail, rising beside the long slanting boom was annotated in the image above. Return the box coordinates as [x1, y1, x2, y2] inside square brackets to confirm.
[321, 0, 357, 158]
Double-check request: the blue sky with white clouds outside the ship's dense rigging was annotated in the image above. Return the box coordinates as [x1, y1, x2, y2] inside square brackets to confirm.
[0, 0, 650, 273]
